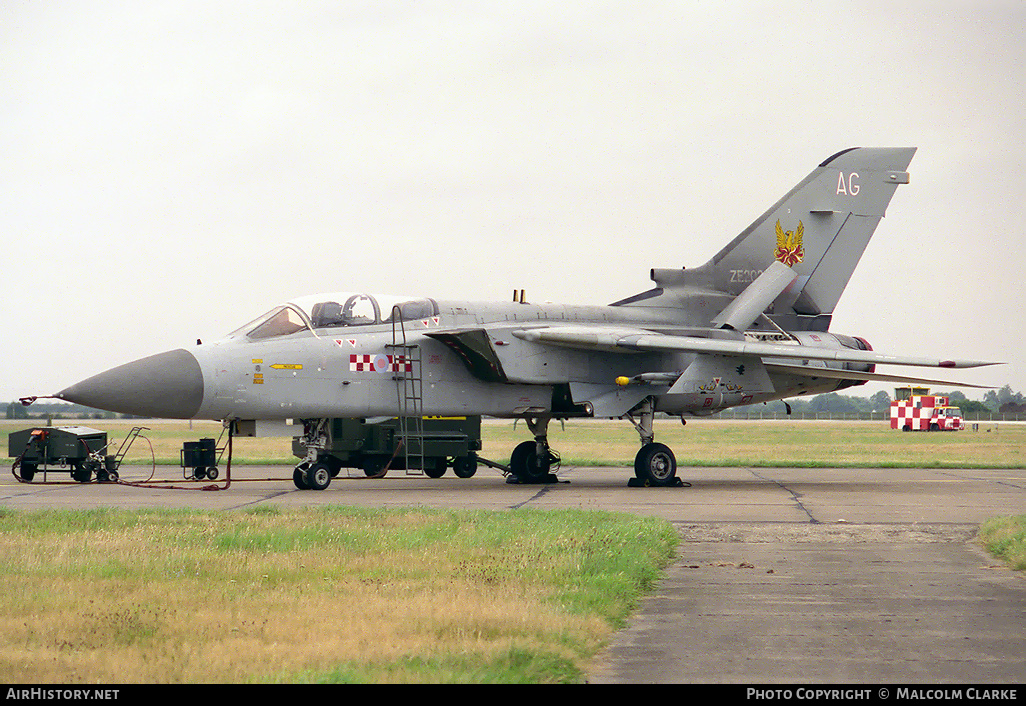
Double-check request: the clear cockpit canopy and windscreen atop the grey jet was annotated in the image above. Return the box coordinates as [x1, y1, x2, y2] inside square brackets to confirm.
[228, 292, 438, 341]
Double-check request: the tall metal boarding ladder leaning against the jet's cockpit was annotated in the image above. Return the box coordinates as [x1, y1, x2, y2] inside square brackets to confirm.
[388, 305, 424, 475]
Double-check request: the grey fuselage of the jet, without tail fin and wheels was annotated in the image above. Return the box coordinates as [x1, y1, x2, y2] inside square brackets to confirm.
[61, 293, 865, 420]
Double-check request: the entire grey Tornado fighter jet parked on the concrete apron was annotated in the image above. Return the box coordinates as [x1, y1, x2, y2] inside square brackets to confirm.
[56, 148, 991, 489]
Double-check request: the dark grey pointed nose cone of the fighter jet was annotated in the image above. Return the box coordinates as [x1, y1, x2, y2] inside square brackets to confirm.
[56, 348, 203, 419]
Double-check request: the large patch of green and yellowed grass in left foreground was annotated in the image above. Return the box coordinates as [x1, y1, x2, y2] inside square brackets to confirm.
[0, 507, 677, 683]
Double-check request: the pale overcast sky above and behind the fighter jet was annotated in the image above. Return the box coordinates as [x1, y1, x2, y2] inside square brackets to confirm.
[0, 0, 1026, 400]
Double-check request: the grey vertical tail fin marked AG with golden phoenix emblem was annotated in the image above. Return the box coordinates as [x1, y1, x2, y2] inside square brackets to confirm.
[699, 148, 915, 326]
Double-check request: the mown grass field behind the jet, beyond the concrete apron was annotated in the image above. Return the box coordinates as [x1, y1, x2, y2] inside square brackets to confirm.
[0, 419, 1026, 468]
